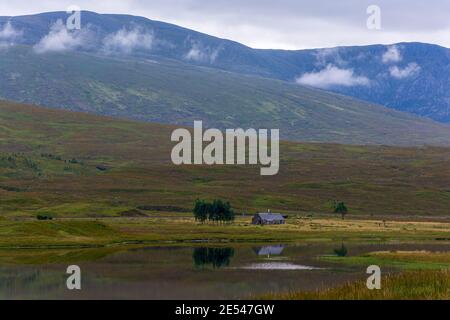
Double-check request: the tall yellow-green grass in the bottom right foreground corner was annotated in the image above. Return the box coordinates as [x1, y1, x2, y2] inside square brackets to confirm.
[259, 270, 450, 300]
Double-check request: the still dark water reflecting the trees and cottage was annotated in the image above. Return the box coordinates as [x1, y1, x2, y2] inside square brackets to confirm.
[0, 243, 450, 299]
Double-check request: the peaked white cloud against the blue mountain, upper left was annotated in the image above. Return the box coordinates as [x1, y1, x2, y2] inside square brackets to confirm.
[34, 20, 89, 53]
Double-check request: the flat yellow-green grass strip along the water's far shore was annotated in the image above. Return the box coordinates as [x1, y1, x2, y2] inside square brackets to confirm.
[0, 213, 450, 249]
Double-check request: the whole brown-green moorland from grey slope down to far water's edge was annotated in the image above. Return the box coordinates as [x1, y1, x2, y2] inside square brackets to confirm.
[0, 102, 450, 260]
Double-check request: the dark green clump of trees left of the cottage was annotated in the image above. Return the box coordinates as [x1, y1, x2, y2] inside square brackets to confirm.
[193, 199, 235, 223]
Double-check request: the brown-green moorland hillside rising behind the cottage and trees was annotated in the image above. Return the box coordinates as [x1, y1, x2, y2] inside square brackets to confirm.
[0, 101, 450, 217]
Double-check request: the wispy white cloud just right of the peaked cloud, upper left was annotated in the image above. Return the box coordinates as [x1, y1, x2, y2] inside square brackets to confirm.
[103, 27, 154, 54]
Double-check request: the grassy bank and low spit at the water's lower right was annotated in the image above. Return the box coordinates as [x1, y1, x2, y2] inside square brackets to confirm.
[260, 251, 450, 300]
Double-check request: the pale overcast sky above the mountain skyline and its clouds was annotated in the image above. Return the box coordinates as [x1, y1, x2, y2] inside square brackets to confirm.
[0, 0, 450, 49]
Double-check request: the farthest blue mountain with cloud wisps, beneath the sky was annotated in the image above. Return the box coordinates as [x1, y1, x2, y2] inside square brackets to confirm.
[0, 12, 450, 122]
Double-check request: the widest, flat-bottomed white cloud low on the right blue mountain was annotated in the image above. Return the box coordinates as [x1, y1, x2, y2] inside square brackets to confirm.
[296, 64, 370, 89]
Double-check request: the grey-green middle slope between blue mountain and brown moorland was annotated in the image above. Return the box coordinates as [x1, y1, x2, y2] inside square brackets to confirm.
[0, 46, 450, 145]
